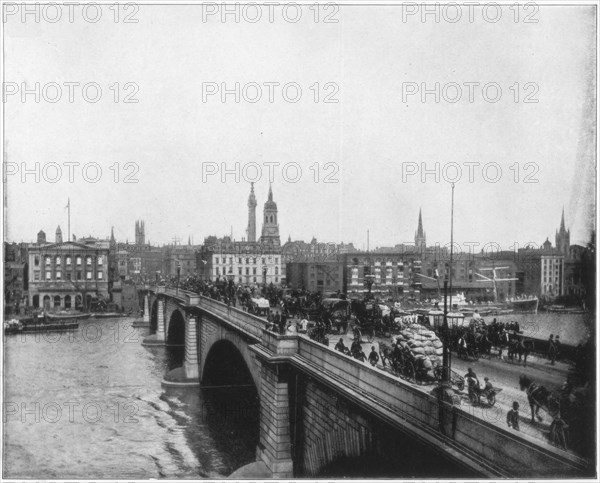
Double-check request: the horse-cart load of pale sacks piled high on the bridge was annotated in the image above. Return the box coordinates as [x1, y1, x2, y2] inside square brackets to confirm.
[381, 324, 443, 382]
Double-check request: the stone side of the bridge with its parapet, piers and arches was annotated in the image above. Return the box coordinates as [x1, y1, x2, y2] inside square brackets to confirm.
[137, 287, 594, 478]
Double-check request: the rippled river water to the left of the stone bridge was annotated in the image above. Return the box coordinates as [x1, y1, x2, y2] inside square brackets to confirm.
[3, 319, 259, 479]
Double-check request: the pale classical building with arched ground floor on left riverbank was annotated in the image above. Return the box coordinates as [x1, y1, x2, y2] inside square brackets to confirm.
[28, 227, 109, 309]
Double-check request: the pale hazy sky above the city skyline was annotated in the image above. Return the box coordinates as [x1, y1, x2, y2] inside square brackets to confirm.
[4, 2, 596, 248]
